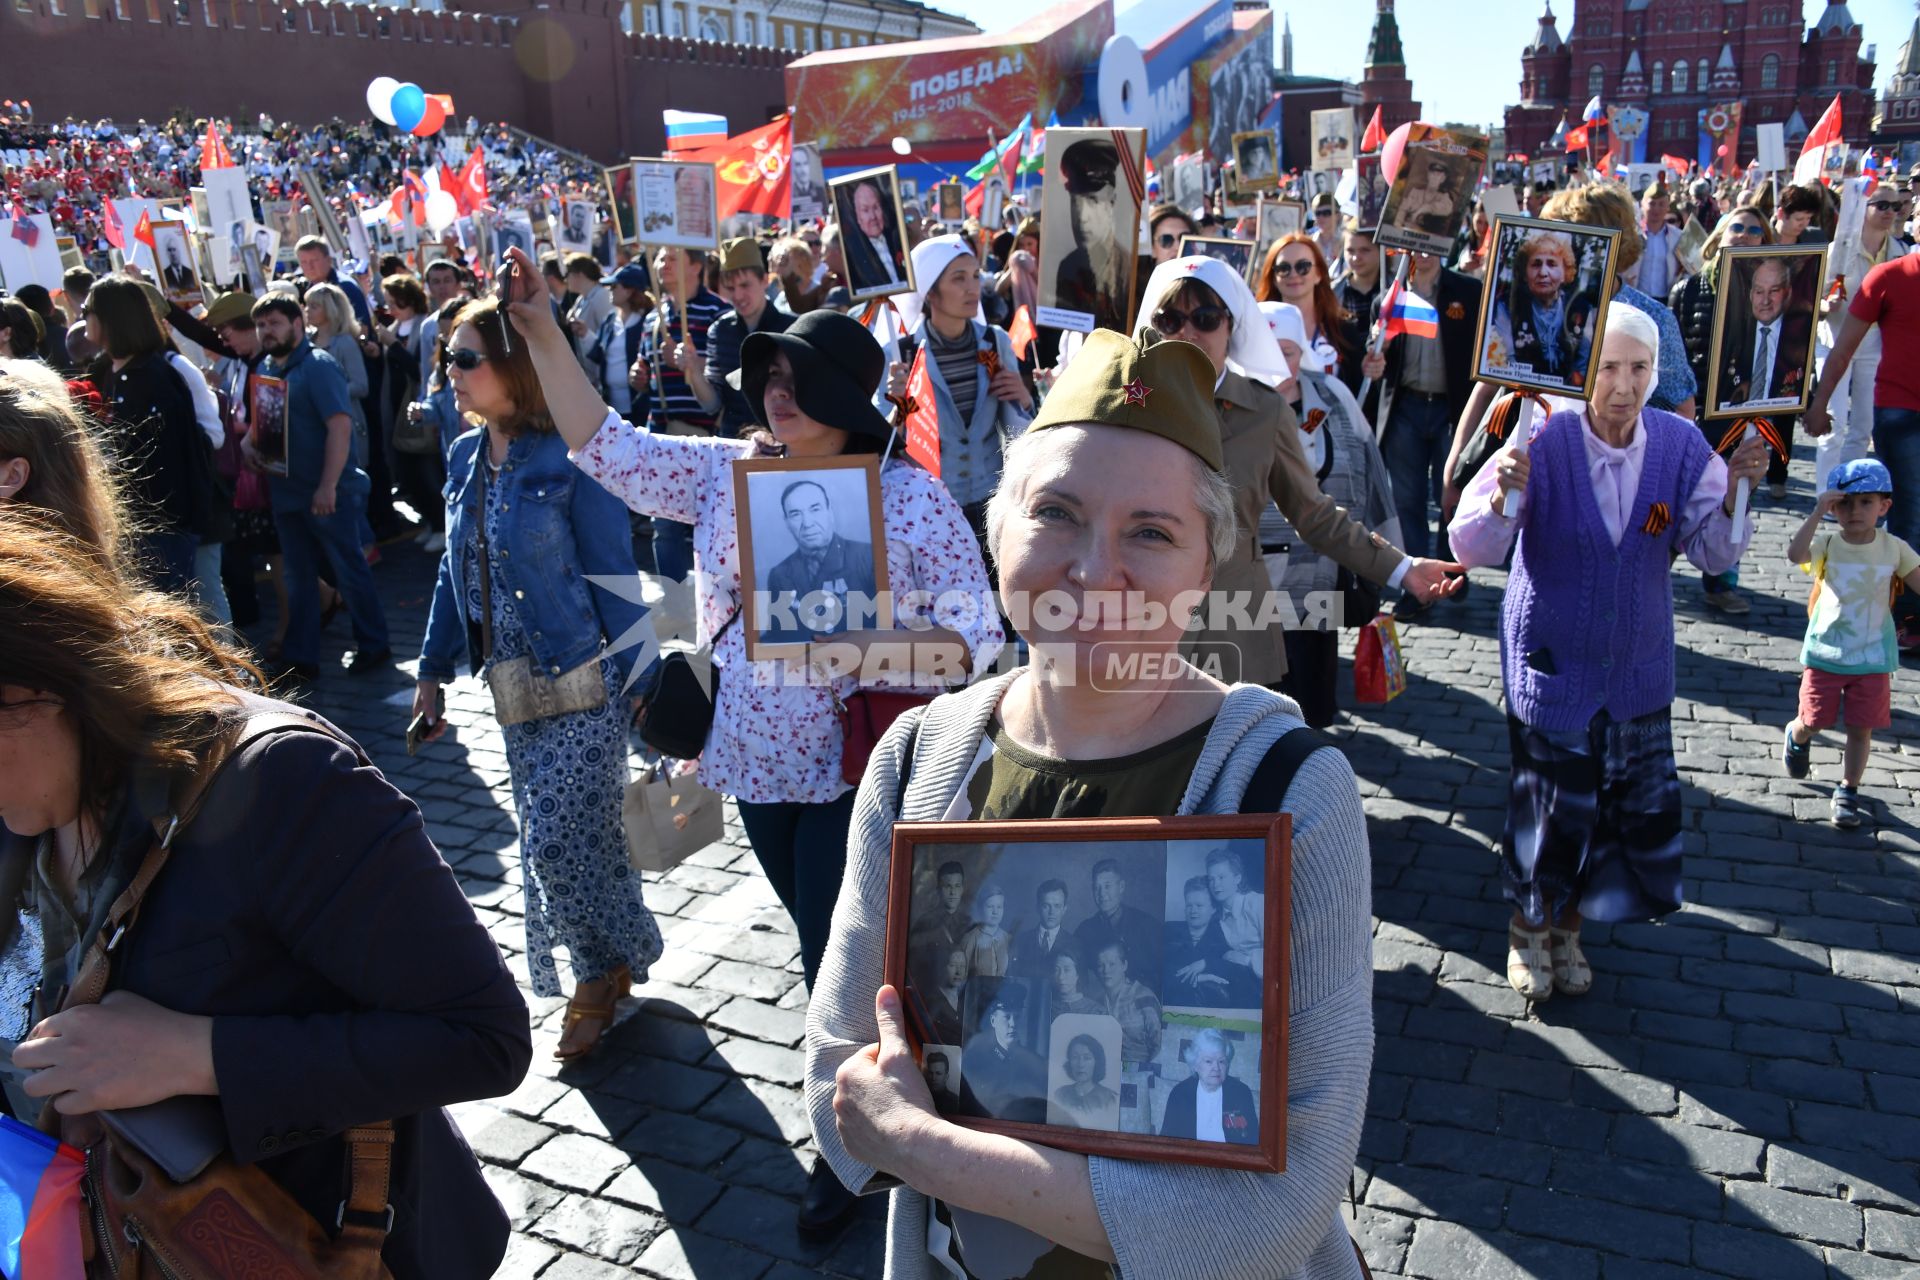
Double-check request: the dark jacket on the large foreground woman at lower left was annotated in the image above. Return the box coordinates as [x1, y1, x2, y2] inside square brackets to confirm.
[0, 699, 532, 1280]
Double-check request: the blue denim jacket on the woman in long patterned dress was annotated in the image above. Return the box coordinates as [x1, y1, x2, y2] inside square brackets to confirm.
[420, 428, 647, 679]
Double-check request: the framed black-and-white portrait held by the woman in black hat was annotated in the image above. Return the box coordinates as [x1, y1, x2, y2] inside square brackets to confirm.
[733, 455, 893, 662]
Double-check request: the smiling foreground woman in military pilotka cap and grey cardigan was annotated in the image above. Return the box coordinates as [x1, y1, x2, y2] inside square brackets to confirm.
[806, 324, 1373, 1280]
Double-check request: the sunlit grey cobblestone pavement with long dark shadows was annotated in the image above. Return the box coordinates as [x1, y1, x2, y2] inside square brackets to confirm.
[266, 451, 1920, 1280]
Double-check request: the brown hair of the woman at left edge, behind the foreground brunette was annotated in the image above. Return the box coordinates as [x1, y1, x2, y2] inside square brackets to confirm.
[0, 361, 125, 564]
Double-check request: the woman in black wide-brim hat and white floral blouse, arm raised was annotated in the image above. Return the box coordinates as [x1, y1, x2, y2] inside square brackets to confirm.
[509, 249, 1004, 1232]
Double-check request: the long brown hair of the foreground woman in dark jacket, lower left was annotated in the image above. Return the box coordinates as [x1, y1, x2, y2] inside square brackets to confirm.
[0, 503, 261, 836]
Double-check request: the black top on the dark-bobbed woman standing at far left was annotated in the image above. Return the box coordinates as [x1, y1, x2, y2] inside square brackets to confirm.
[94, 351, 215, 533]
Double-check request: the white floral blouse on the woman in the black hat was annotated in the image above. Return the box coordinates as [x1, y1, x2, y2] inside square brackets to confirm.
[570, 411, 1006, 804]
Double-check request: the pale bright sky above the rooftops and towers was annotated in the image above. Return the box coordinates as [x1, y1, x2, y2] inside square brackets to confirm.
[927, 0, 1914, 125]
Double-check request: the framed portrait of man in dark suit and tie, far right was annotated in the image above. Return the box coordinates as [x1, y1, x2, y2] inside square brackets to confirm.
[1701, 244, 1826, 418]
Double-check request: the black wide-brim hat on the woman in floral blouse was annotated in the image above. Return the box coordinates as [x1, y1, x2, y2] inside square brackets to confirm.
[739, 311, 893, 439]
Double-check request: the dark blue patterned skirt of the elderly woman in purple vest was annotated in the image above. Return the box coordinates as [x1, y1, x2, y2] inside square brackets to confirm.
[1500, 710, 1682, 929]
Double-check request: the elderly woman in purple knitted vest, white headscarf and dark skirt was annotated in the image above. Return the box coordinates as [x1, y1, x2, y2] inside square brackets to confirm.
[1448, 301, 1766, 1000]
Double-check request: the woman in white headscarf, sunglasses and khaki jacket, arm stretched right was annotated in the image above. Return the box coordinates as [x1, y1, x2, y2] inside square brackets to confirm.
[1139, 257, 1459, 693]
